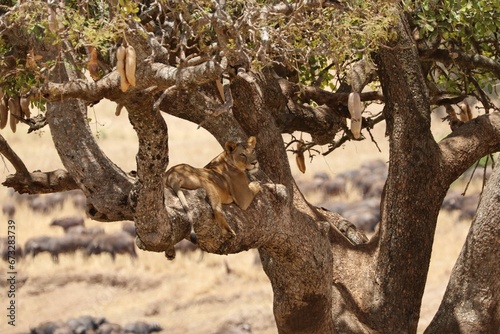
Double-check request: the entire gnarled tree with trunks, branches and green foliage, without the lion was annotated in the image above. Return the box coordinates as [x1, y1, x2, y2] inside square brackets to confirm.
[0, 0, 500, 333]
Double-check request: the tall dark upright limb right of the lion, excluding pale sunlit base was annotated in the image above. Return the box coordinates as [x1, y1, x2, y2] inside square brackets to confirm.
[372, 13, 442, 332]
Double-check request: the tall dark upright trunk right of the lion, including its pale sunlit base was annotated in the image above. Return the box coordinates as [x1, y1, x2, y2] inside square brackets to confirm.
[334, 9, 448, 333]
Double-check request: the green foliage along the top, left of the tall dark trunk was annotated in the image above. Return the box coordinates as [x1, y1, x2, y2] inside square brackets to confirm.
[2, 0, 395, 94]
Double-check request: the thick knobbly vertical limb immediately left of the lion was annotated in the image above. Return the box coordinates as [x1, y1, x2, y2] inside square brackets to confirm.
[126, 94, 180, 259]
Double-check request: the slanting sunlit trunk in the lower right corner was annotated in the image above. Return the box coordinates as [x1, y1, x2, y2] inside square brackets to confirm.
[425, 166, 500, 334]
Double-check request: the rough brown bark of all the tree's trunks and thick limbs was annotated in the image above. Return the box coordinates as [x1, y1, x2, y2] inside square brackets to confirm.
[0, 3, 500, 333]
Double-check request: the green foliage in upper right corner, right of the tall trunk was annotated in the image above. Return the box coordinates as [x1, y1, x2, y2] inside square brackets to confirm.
[405, 0, 500, 104]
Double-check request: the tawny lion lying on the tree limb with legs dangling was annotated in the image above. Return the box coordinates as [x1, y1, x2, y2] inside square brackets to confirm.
[165, 136, 261, 243]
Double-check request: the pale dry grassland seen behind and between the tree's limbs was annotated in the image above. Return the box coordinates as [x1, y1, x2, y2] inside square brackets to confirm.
[0, 102, 476, 334]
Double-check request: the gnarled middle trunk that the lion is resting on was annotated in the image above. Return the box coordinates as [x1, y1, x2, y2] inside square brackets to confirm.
[167, 72, 333, 333]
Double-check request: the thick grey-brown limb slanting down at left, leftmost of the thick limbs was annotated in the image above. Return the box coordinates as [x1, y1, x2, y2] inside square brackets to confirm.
[46, 58, 133, 221]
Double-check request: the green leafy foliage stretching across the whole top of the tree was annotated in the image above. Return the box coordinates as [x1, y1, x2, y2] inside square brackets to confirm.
[0, 0, 500, 120]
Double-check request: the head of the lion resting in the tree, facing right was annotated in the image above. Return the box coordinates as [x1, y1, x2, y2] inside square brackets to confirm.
[225, 136, 259, 173]
